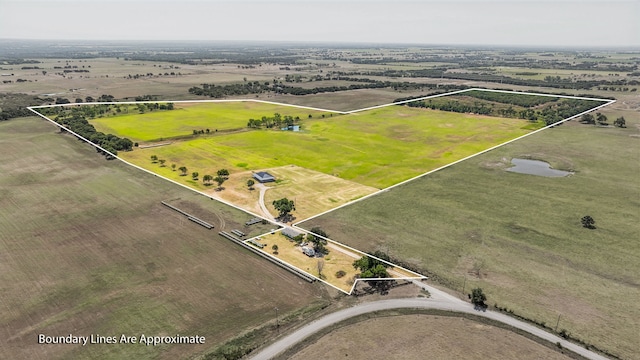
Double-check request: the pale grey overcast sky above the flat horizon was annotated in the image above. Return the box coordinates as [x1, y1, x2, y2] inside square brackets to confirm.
[0, 0, 640, 49]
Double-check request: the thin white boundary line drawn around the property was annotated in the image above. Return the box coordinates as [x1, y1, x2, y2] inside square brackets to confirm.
[27, 88, 616, 295]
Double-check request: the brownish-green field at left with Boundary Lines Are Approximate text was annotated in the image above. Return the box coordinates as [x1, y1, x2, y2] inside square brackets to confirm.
[0, 118, 326, 359]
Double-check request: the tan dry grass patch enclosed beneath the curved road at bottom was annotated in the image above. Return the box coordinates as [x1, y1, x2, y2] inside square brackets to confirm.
[289, 314, 570, 360]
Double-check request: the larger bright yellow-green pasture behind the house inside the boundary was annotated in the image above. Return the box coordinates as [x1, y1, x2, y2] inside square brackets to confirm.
[116, 106, 530, 189]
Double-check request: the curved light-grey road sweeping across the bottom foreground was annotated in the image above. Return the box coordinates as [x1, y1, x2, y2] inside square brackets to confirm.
[251, 281, 607, 360]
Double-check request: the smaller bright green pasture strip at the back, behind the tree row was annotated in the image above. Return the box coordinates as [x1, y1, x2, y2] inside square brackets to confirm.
[91, 101, 336, 142]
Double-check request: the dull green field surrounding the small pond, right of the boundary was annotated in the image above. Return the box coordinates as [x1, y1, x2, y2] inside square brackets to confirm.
[302, 120, 640, 359]
